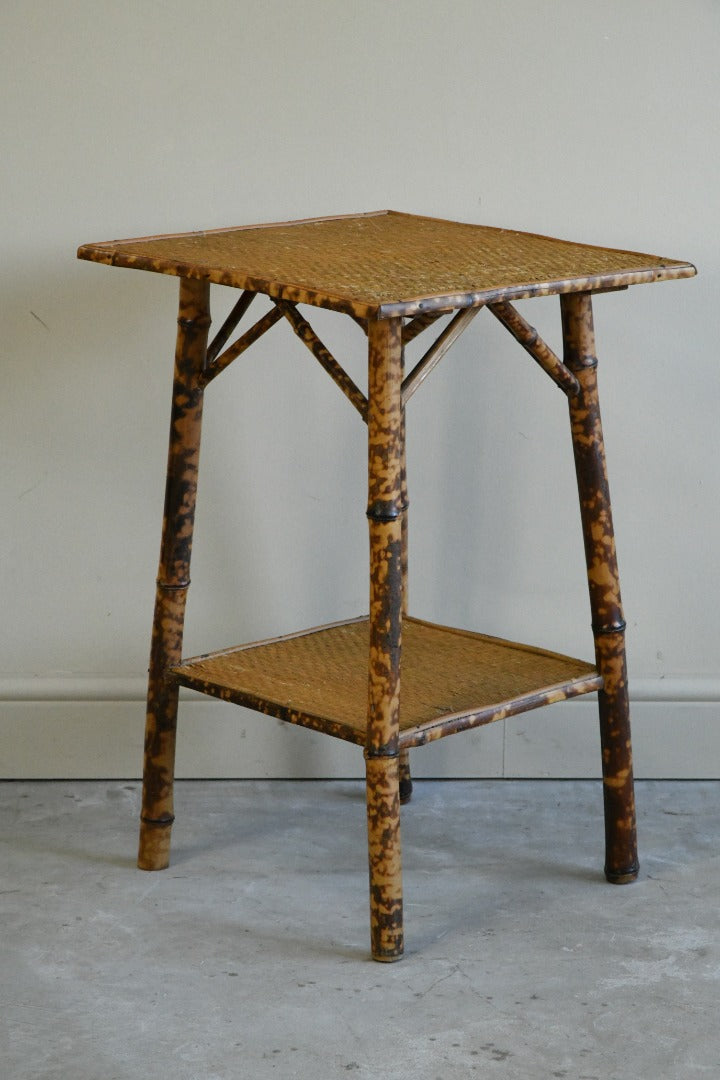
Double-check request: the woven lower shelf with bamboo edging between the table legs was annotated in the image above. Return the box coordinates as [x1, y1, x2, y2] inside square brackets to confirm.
[171, 616, 602, 748]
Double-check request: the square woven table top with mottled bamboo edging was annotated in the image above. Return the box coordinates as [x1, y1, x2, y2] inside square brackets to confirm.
[78, 211, 695, 319]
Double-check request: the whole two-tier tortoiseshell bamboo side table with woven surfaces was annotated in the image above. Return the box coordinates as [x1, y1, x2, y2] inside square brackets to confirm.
[78, 212, 695, 960]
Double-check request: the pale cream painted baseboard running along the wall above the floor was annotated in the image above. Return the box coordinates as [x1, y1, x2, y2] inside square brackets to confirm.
[0, 677, 720, 780]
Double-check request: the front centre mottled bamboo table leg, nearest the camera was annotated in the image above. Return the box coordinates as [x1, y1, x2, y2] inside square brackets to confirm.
[365, 319, 405, 961]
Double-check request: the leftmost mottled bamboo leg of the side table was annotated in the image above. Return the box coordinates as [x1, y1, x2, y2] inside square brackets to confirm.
[137, 279, 210, 870]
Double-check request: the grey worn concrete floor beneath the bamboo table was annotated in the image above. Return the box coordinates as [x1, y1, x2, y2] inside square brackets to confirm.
[0, 781, 720, 1080]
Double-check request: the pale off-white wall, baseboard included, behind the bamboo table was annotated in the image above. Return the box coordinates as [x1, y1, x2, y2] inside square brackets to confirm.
[0, 0, 720, 777]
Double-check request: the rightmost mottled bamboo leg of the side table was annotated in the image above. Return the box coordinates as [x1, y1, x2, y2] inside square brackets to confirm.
[560, 293, 638, 885]
